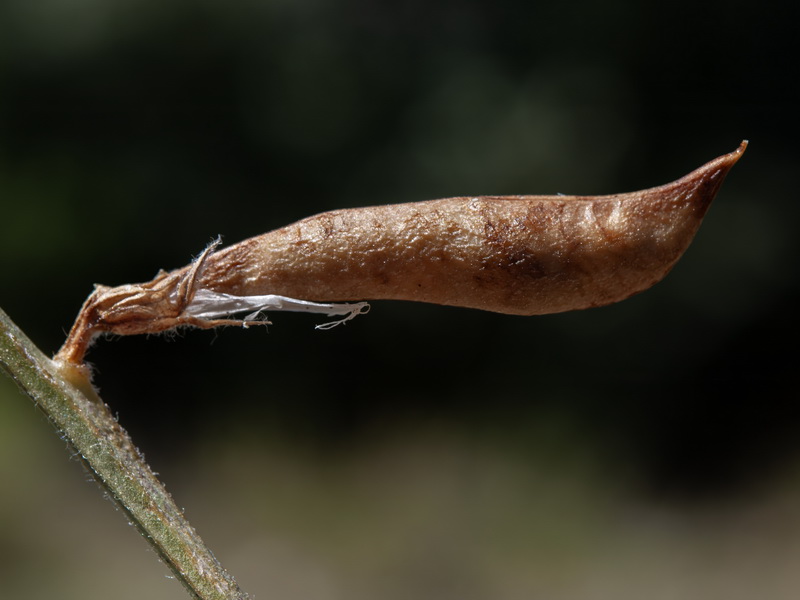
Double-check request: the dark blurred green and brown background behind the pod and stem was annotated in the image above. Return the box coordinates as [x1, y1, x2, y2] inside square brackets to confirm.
[0, 0, 800, 600]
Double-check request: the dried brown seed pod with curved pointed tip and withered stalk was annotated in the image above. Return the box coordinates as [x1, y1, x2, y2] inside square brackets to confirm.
[55, 141, 747, 365]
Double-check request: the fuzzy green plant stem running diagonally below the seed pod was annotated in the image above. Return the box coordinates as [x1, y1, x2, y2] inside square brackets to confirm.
[0, 309, 248, 600]
